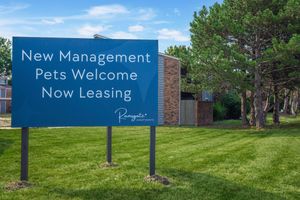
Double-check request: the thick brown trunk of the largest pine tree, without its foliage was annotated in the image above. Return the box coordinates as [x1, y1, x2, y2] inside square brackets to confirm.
[254, 65, 265, 129]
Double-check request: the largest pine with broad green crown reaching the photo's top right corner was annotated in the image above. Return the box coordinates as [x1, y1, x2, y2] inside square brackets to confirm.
[191, 0, 300, 128]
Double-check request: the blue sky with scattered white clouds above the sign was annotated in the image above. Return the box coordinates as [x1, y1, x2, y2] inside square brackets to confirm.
[0, 0, 222, 52]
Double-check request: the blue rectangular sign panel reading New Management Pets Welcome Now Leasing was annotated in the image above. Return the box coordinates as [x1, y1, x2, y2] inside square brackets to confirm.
[12, 37, 158, 127]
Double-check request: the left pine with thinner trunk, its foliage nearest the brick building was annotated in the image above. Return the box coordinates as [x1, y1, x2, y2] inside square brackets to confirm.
[191, 4, 252, 125]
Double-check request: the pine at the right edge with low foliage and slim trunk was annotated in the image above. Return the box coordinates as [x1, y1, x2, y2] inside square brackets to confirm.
[263, 34, 300, 124]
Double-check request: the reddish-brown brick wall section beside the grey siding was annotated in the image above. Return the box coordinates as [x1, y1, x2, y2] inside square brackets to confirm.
[164, 56, 180, 125]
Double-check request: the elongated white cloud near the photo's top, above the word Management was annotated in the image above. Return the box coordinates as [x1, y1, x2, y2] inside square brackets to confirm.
[87, 4, 129, 17]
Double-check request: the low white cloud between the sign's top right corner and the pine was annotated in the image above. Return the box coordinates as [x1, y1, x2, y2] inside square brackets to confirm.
[158, 28, 190, 42]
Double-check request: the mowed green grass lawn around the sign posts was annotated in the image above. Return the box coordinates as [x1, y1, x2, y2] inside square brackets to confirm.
[0, 115, 300, 200]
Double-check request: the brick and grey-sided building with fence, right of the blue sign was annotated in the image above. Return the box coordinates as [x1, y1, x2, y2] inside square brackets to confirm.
[158, 53, 213, 126]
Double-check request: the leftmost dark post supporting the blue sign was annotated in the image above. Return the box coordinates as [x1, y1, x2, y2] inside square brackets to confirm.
[20, 128, 29, 181]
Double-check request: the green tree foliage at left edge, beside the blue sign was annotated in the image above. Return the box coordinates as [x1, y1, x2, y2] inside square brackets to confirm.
[0, 37, 12, 76]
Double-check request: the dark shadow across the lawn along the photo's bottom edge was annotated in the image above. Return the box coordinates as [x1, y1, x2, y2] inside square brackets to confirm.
[51, 169, 284, 200]
